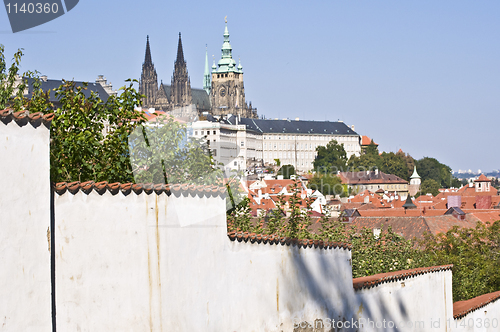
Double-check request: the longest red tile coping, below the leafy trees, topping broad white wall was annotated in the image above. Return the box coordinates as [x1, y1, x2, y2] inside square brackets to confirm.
[54, 181, 226, 197]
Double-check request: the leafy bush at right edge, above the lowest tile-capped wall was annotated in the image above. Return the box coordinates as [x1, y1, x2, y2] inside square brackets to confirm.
[420, 221, 500, 301]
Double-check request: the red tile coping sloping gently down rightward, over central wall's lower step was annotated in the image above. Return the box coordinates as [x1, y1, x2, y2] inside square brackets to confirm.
[227, 231, 351, 250]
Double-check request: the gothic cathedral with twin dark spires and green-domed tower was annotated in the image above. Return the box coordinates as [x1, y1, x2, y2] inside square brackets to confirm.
[139, 21, 257, 118]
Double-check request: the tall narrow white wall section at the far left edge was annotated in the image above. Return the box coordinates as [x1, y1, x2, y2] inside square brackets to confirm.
[0, 122, 52, 331]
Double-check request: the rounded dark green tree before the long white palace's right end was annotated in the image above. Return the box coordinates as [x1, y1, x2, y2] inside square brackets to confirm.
[313, 140, 347, 175]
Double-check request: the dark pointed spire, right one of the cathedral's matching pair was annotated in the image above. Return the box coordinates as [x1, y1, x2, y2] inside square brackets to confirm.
[170, 32, 192, 107]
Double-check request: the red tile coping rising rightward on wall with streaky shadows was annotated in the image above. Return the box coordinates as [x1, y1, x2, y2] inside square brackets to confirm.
[352, 264, 453, 290]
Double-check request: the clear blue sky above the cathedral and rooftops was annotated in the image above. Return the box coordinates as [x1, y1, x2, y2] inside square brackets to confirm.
[0, 0, 500, 171]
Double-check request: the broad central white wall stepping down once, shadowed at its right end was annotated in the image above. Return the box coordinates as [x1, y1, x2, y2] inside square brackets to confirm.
[56, 192, 353, 331]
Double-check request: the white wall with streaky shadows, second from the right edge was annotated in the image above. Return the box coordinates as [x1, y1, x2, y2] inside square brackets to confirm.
[356, 270, 453, 332]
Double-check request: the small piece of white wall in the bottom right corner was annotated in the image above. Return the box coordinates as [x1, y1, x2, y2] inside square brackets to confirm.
[451, 299, 500, 332]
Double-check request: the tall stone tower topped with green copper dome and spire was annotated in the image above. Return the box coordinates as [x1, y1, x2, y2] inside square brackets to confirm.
[210, 20, 257, 118]
